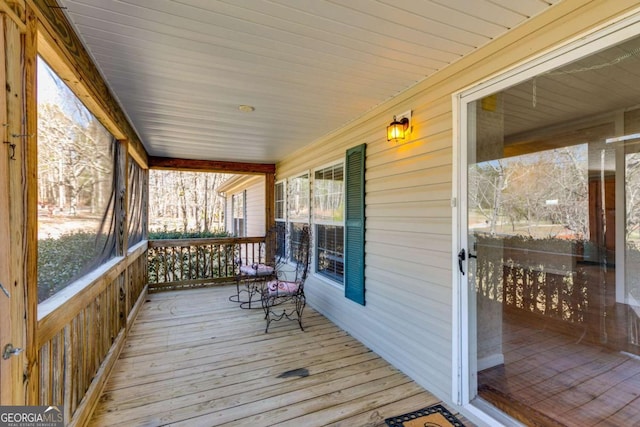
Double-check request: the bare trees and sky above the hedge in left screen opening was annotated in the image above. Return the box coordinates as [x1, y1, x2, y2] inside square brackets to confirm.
[38, 60, 115, 231]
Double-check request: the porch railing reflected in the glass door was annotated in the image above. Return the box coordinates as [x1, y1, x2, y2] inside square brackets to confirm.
[474, 237, 640, 354]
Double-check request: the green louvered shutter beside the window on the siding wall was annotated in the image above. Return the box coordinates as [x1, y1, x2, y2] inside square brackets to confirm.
[344, 144, 366, 305]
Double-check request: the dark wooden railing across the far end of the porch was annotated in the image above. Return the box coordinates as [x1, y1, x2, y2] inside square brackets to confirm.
[148, 237, 265, 292]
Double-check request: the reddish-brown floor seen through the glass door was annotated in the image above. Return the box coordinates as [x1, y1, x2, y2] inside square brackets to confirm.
[478, 310, 640, 427]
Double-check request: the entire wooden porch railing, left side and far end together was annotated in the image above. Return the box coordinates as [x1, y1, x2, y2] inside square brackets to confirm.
[37, 237, 265, 426]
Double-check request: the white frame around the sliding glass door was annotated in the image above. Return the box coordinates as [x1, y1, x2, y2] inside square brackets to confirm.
[451, 9, 640, 427]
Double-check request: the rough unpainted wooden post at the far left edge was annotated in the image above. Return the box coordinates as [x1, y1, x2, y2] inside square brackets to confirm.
[0, 5, 37, 405]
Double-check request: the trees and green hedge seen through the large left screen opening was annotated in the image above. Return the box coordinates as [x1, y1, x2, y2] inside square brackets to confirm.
[38, 60, 117, 302]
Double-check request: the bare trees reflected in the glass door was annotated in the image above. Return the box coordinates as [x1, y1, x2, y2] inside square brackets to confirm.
[469, 144, 640, 248]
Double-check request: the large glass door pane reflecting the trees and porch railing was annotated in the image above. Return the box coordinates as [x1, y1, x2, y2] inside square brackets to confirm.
[466, 34, 640, 427]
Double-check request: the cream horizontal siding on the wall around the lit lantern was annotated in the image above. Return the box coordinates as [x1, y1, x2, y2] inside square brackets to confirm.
[278, 105, 452, 397]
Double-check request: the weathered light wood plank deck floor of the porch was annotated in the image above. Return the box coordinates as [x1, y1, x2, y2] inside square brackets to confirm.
[90, 287, 464, 427]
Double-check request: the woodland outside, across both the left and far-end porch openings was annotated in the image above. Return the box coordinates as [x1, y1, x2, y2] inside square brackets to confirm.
[38, 59, 231, 302]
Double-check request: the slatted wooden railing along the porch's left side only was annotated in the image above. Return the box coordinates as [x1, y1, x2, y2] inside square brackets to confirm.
[37, 242, 147, 426]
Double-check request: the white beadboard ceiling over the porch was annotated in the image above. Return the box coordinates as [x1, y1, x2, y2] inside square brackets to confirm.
[59, 0, 559, 163]
